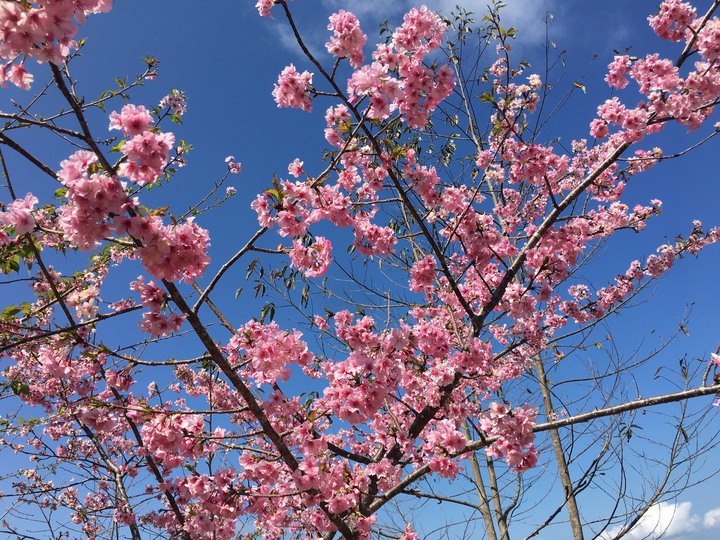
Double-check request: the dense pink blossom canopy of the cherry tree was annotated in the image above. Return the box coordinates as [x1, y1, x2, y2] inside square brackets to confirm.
[0, 0, 720, 540]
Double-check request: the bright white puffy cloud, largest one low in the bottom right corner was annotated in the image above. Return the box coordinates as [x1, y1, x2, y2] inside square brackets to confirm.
[603, 502, 696, 540]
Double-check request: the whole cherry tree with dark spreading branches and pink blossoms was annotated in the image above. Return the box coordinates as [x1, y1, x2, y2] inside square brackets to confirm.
[0, 0, 720, 540]
